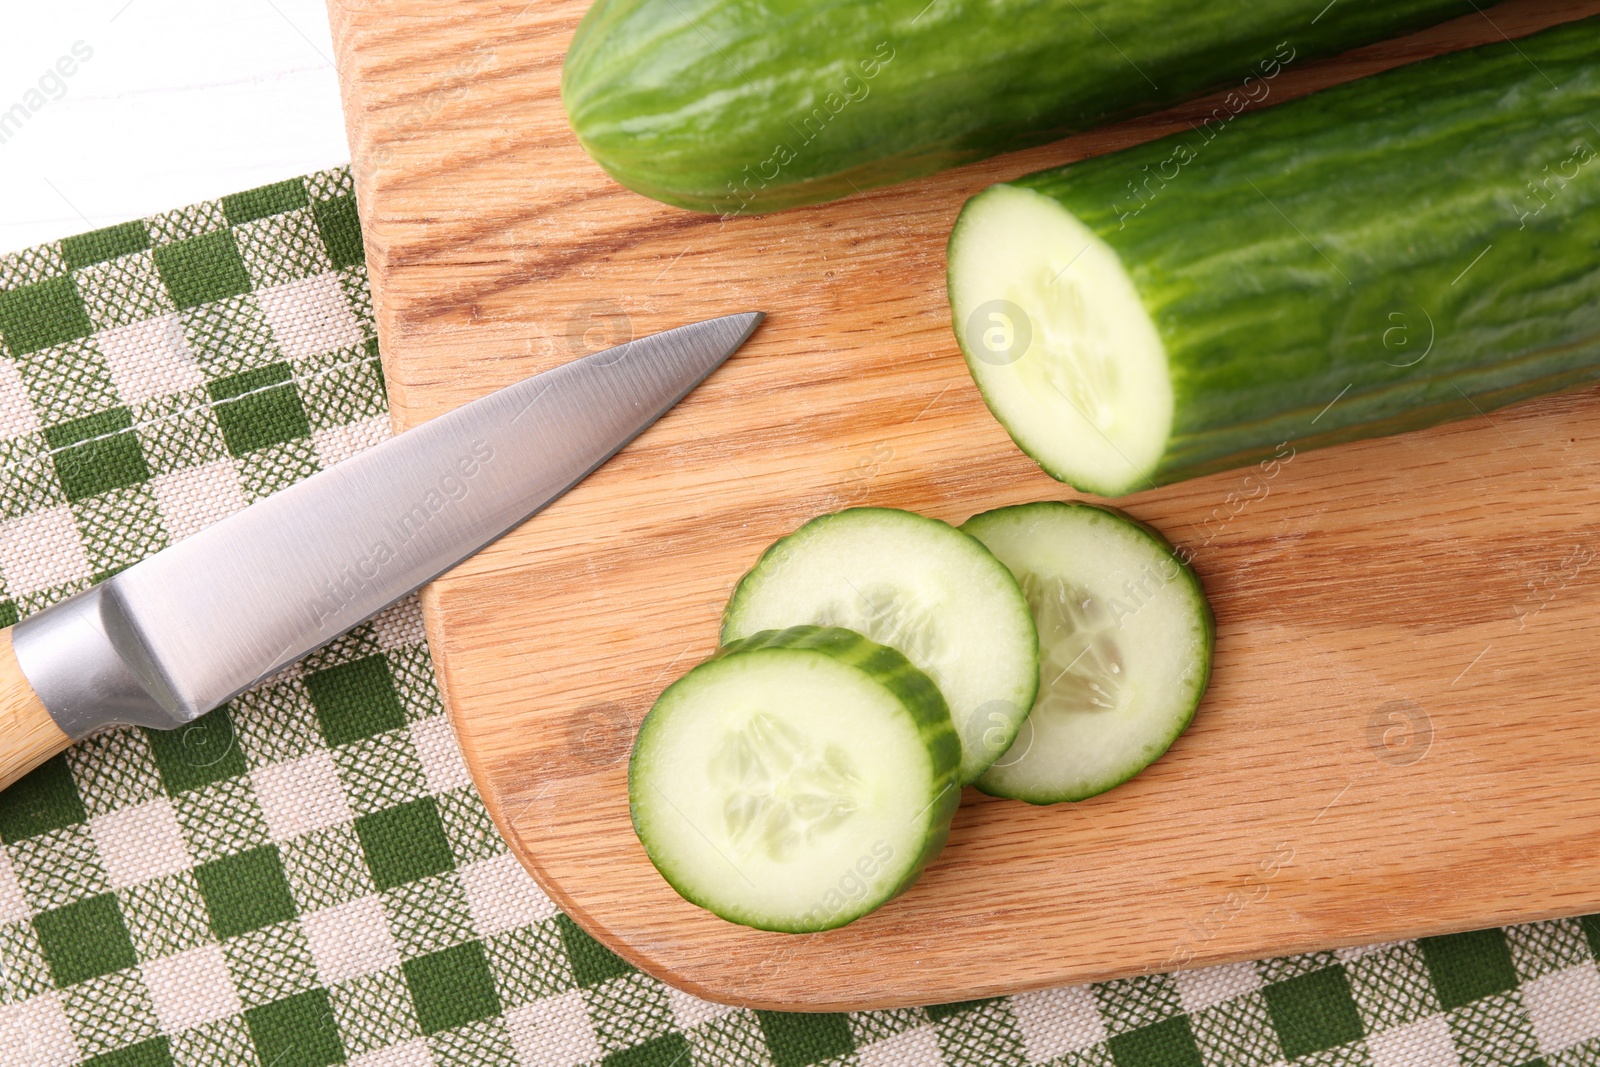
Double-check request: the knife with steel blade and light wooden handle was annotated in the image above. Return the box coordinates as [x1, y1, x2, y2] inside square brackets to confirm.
[0, 312, 763, 789]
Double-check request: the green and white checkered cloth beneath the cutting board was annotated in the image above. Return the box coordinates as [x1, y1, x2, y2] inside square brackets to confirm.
[0, 170, 1600, 1067]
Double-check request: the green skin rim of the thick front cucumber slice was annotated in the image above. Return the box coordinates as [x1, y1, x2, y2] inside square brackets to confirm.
[627, 625, 962, 934]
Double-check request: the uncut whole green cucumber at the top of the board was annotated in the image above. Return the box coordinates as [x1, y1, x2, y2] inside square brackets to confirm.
[562, 0, 1474, 214]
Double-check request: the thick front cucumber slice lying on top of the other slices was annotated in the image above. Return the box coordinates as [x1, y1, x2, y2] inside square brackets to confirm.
[627, 625, 960, 933]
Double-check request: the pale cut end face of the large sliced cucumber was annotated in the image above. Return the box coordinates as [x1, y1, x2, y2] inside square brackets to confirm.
[949, 186, 1173, 496]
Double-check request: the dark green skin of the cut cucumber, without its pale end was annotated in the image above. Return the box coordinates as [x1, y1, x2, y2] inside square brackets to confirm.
[985, 18, 1600, 485]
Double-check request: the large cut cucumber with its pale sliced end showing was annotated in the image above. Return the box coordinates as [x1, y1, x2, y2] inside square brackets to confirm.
[949, 19, 1600, 496]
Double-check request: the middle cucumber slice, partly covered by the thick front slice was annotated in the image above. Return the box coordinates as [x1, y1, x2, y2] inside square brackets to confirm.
[722, 507, 1038, 784]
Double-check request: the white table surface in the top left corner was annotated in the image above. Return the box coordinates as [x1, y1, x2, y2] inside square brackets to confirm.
[0, 0, 350, 253]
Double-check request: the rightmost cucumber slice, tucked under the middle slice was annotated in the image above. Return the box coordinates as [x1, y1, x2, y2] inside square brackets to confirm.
[962, 501, 1216, 805]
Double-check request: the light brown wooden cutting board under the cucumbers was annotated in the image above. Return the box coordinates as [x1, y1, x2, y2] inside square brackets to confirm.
[331, 0, 1600, 1009]
